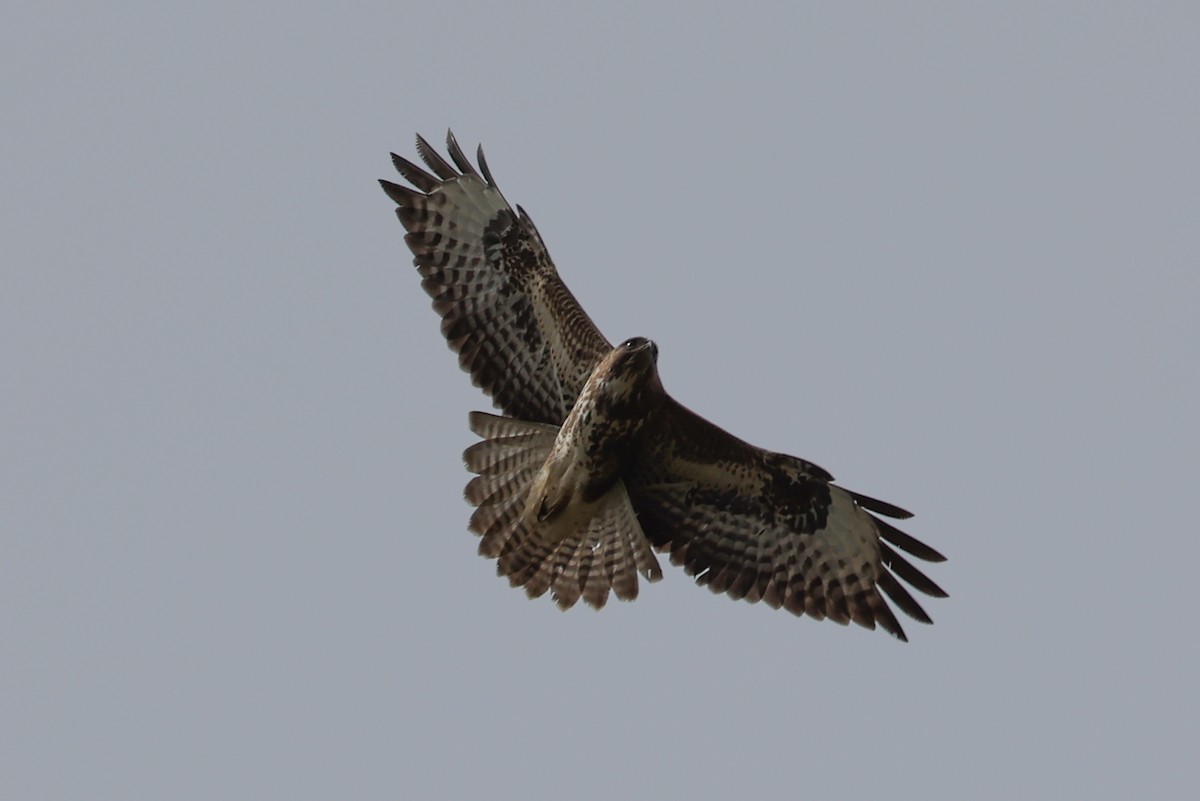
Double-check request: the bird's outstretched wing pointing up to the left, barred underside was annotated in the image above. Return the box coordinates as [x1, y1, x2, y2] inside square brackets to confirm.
[379, 133, 612, 424]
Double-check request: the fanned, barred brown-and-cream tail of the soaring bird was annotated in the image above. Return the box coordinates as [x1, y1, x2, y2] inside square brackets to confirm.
[463, 411, 662, 609]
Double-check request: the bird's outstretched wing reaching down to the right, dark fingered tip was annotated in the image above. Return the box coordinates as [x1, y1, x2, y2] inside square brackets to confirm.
[625, 401, 946, 640]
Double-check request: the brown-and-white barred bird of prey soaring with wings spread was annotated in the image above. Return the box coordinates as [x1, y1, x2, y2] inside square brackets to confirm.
[380, 133, 946, 640]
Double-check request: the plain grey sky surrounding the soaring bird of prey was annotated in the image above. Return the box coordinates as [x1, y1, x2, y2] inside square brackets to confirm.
[0, 1, 1200, 800]
